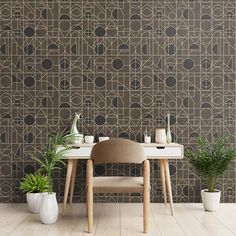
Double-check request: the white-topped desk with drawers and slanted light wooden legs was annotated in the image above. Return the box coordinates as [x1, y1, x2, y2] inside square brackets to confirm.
[58, 143, 184, 215]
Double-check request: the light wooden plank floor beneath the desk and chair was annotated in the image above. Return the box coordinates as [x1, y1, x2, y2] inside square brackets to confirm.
[0, 203, 236, 236]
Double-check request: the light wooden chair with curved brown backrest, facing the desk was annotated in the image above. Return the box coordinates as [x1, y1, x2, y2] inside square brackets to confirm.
[87, 139, 150, 233]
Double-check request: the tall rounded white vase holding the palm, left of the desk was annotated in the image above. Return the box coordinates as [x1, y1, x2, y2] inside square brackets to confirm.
[39, 193, 58, 224]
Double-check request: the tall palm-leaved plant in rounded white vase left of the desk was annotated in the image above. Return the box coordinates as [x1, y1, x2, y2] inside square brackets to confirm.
[32, 134, 69, 224]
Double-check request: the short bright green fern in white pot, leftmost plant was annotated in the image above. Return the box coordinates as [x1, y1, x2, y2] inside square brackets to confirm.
[20, 172, 49, 213]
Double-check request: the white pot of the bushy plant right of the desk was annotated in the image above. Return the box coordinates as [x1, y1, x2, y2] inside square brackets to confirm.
[201, 189, 221, 211]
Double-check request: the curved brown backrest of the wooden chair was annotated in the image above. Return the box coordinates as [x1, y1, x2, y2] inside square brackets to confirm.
[91, 139, 146, 164]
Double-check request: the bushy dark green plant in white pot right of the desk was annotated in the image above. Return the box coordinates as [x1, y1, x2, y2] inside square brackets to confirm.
[185, 136, 236, 211]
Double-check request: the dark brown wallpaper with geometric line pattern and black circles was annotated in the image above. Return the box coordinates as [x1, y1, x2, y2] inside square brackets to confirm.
[0, 0, 236, 202]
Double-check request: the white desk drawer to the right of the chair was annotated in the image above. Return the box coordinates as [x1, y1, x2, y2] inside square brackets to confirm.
[144, 146, 183, 158]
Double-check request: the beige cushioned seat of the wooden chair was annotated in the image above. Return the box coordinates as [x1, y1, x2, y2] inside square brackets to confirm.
[93, 176, 143, 193]
